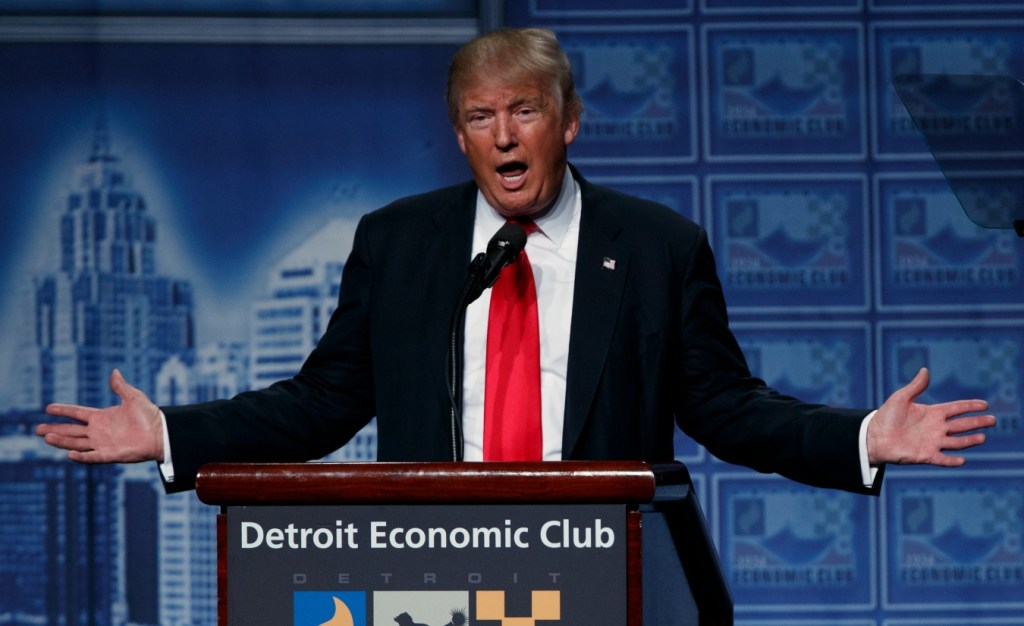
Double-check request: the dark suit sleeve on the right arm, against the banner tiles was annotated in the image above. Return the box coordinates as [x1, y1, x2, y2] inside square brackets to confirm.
[673, 231, 881, 493]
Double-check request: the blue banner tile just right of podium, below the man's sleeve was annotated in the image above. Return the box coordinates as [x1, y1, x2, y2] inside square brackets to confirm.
[713, 473, 877, 613]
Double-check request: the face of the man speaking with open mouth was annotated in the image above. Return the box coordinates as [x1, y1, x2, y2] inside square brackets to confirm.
[455, 79, 580, 217]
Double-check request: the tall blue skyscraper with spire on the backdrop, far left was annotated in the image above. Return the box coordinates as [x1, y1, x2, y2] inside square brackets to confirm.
[24, 121, 195, 406]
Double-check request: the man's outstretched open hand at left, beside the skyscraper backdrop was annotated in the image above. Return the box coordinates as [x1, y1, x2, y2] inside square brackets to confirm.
[36, 370, 164, 463]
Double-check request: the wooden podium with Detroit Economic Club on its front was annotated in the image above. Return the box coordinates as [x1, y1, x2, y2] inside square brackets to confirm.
[197, 461, 732, 626]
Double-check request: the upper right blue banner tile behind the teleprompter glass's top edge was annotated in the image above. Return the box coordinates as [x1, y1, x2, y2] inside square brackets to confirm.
[870, 21, 1024, 160]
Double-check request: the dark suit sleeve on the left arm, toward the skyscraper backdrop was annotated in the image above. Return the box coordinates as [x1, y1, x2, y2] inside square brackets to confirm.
[163, 215, 375, 492]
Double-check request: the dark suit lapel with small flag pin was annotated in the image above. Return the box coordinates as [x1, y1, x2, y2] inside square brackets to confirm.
[562, 175, 630, 459]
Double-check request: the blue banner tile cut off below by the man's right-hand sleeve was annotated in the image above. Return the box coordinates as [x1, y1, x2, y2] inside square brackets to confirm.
[733, 323, 873, 407]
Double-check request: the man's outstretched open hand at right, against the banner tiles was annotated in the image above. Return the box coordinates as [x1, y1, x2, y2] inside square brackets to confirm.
[867, 369, 995, 467]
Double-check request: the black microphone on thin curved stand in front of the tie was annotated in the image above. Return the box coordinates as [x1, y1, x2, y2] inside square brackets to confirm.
[444, 221, 526, 461]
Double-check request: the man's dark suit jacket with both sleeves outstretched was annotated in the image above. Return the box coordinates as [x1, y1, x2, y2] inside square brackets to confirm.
[165, 170, 881, 491]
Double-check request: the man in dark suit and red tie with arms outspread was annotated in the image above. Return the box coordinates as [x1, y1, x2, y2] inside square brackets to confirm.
[37, 29, 994, 493]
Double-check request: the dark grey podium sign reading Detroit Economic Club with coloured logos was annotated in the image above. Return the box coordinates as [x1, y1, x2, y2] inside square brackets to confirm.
[227, 504, 627, 626]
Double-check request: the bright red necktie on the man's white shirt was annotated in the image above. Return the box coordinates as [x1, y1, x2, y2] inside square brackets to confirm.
[483, 221, 542, 461]
